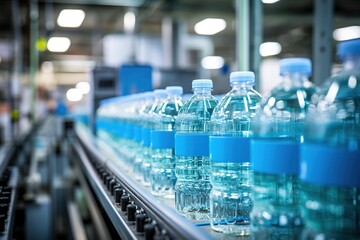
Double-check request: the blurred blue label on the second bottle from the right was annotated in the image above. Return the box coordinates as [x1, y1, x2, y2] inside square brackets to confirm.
[250, 138, 300, 175]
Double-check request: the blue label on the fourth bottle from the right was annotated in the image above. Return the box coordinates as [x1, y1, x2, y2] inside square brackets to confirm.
[175, 133, 209, 157]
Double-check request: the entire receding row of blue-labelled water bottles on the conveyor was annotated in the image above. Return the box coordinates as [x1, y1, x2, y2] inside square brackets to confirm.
[88, 40, 360, 239]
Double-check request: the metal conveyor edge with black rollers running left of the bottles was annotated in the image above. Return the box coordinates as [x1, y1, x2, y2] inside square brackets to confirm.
[71, 126, 212, 239]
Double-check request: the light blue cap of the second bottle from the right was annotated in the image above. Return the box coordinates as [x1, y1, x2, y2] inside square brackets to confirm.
[280, 58, 311, 76]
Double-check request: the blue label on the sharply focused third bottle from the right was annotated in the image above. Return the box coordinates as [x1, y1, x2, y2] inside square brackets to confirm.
[210, 136, 250, 162]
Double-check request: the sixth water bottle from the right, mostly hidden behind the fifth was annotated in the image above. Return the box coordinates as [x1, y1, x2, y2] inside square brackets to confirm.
[141, 89, 167, 186]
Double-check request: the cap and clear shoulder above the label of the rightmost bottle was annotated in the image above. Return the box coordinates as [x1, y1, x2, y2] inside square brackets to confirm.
[306, 39, 360, 148]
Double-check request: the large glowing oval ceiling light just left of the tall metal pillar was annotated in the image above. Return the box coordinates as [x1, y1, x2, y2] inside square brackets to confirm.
[194, 18, 226, 35]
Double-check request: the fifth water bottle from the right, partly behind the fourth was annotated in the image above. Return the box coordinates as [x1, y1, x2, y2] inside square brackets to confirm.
[150, 86, 183, 198]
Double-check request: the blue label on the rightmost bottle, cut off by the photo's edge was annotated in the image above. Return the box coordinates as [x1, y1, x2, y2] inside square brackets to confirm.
[300, 144, 360, 187]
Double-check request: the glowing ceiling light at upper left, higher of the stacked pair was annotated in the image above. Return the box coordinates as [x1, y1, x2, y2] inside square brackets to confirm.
[57, 9, 85, 28]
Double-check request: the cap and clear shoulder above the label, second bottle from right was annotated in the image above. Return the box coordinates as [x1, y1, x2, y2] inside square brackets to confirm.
[255, 58, 319, 142]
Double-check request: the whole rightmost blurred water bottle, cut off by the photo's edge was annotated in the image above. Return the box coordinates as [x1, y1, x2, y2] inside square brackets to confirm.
[300, 39, 360, 239]
